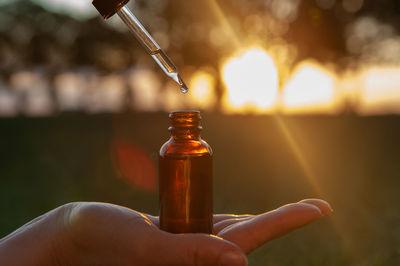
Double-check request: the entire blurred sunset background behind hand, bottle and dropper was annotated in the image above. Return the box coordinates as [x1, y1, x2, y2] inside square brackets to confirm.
[0, 0, 400, 266]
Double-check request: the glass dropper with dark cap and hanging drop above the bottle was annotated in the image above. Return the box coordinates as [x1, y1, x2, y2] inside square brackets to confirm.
[92, 0, 189, 93]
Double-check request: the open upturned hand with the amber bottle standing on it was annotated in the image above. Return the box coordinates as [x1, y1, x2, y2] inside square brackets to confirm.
[0, 199, 331, 266]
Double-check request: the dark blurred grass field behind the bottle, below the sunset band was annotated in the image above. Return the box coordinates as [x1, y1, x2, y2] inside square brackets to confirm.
[0, 113, 400, 266]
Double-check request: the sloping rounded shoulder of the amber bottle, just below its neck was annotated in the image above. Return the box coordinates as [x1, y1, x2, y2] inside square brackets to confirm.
[160, 138, 213, 157]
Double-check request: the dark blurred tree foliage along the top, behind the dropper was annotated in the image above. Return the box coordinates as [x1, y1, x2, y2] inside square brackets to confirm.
[0, 0, 400, 71]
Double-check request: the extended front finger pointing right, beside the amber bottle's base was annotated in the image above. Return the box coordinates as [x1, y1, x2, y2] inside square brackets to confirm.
[218, 203, 322, 254]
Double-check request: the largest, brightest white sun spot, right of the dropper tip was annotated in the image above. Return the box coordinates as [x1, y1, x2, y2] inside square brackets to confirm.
[222, 47, 278, 113]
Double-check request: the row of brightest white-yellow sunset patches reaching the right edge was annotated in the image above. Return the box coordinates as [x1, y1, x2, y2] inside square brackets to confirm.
[221, 48, 400, 114]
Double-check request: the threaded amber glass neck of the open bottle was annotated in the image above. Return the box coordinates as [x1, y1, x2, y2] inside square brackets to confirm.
[168, 111, 202, 141]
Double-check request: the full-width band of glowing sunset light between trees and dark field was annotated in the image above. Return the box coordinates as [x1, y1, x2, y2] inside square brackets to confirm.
[0, 51, 400, 116]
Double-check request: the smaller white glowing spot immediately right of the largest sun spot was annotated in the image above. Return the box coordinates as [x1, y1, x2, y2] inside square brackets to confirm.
[282, 62, 336, 113]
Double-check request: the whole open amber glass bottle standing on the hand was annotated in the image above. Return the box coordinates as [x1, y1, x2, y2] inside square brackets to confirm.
[158, 111, 213, 234]
